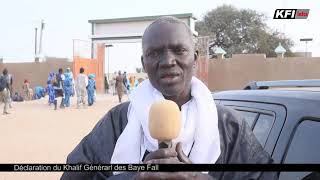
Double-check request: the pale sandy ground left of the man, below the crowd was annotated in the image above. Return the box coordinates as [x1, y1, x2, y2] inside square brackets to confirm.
[0, 95, 127, 180]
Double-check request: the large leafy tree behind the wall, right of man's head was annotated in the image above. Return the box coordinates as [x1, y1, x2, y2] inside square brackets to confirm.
[196, 5, 293, 57]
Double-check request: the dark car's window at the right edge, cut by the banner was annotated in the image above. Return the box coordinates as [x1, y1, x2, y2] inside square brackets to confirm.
[280, 120, 320, 180]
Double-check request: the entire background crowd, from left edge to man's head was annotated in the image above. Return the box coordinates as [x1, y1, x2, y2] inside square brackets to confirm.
[0, 64, 139, 114]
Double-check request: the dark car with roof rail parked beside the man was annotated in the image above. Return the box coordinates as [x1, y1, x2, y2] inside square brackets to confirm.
[213, 80, 320, 180]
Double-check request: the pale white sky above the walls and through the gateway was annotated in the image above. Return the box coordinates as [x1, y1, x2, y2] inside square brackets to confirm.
[0, 0, 320, 72]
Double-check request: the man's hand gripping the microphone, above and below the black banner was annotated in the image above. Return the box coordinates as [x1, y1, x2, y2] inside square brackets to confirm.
[135, 143, 212, 180]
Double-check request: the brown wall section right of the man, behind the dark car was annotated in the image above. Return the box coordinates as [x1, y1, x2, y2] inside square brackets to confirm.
[204, 55, 320, 91]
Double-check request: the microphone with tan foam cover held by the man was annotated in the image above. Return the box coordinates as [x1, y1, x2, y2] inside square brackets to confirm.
[149, 100, 181, 149]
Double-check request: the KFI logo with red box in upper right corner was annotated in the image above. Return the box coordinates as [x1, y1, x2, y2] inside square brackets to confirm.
[273, 9, 310, 19]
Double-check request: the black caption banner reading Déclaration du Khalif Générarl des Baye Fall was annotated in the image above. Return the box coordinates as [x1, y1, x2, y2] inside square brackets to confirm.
[0, 164, 320, 172]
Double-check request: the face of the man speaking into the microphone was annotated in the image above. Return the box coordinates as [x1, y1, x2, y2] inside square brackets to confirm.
[142, 23, 197, 97]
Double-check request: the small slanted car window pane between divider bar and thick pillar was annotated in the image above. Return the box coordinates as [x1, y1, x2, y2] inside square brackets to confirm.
[253, 114, 274, 146]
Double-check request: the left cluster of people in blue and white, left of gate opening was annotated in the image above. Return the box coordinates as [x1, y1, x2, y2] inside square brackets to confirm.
[0, 68, 96, 114]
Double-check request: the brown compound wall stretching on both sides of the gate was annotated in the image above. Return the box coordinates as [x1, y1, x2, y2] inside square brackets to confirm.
[0, 54, 320, 92]
